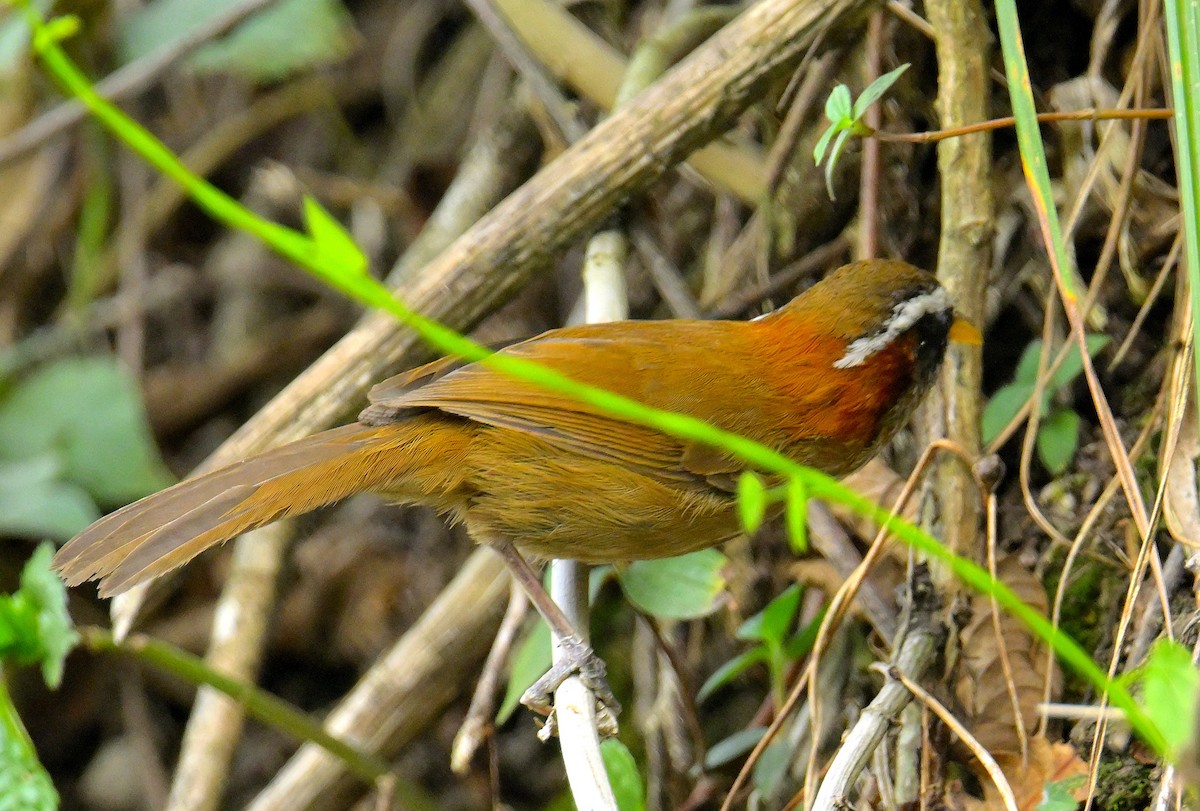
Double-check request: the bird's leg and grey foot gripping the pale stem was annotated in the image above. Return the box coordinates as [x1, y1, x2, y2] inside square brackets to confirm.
[490, 539, 620, 734]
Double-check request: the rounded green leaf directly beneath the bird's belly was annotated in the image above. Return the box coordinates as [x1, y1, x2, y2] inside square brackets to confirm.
[617, 549, 728, 619]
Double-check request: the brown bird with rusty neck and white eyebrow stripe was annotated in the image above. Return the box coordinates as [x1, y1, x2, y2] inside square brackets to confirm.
[54, 259, 980, 715]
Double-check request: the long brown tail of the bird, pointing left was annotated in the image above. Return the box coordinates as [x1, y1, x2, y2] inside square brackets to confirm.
[54, 415, 470, 596]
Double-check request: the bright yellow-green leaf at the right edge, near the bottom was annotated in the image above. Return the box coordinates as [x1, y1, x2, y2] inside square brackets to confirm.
[1140, 639, 1200, 759]
